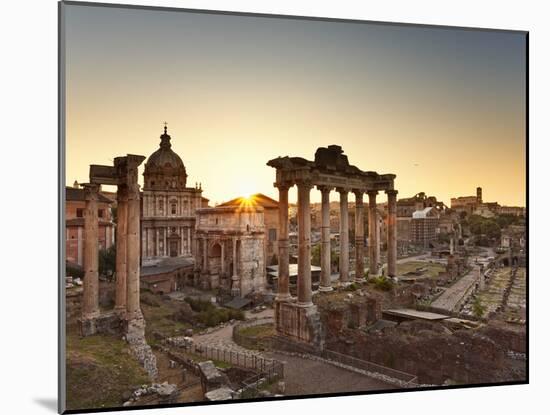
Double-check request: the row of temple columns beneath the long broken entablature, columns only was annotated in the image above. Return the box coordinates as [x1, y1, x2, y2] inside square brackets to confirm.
[276, 182, 397, 307]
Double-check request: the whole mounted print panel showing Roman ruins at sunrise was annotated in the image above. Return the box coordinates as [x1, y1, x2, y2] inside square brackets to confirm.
[59, 1, 528, 413]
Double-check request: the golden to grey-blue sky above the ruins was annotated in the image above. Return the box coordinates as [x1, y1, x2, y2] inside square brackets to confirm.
[65, 5, 526, 206]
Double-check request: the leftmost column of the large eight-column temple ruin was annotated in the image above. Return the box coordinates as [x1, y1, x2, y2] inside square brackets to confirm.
[277, 184, 291, 301]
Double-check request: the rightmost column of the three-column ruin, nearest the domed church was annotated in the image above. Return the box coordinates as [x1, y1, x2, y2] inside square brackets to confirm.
[126, 156, 145, 320]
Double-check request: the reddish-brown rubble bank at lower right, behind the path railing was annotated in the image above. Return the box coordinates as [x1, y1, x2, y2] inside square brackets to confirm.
[326, 321, 522, 384]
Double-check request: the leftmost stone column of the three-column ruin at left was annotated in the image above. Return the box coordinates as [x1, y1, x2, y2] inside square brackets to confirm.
[82, 184, 99, 320]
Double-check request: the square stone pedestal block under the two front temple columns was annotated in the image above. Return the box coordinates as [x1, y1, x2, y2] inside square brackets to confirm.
[275, 301, 324, 351]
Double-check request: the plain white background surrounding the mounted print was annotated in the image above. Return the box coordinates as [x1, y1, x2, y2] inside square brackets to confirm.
[0, 0, 550, 415]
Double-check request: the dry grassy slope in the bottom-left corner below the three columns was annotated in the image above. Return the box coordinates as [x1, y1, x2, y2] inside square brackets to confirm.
[67, 333, 149, 409]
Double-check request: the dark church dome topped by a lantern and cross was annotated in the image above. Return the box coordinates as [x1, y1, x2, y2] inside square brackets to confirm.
[143, 126, 187, 190]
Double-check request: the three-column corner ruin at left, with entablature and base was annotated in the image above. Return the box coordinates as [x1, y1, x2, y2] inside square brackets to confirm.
[75, 154, 157, 379]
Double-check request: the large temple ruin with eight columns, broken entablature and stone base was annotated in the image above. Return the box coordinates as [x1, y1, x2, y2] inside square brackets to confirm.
[267, 145, 397, 348]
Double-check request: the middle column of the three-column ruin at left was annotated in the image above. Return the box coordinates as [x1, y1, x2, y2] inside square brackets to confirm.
[115, 185, 128, 314]
